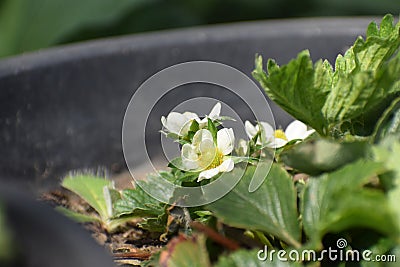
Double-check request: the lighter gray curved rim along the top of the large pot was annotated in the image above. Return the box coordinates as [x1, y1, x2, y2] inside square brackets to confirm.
[0, 16, 380, 78]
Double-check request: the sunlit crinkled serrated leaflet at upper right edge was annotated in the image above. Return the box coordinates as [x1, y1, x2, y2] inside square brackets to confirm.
[323, 15, 400, 129]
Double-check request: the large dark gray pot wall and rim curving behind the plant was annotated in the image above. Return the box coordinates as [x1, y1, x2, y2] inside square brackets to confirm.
[0, 18, 371, 266]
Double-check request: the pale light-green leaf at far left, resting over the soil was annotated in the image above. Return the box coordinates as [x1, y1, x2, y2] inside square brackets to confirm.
[61, 175, 112, 222]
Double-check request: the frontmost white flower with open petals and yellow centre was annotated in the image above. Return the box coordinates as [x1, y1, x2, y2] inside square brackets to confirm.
[181, 128, 235, 181]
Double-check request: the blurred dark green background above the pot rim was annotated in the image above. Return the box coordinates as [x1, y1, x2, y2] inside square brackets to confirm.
[0, 0, 400, 57]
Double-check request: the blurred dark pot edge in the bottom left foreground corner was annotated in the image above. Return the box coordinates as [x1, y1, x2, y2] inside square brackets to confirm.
[0, 182, 114, 267]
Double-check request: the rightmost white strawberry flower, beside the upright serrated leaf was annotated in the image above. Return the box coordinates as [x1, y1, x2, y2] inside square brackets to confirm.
[245, 120, 315, 148]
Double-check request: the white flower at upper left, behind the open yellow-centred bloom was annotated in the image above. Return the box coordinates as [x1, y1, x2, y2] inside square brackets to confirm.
[161, 112, 199, 136]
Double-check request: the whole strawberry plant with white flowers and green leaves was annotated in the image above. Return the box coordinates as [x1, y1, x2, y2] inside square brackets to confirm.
[59, 15, 400, 267]
